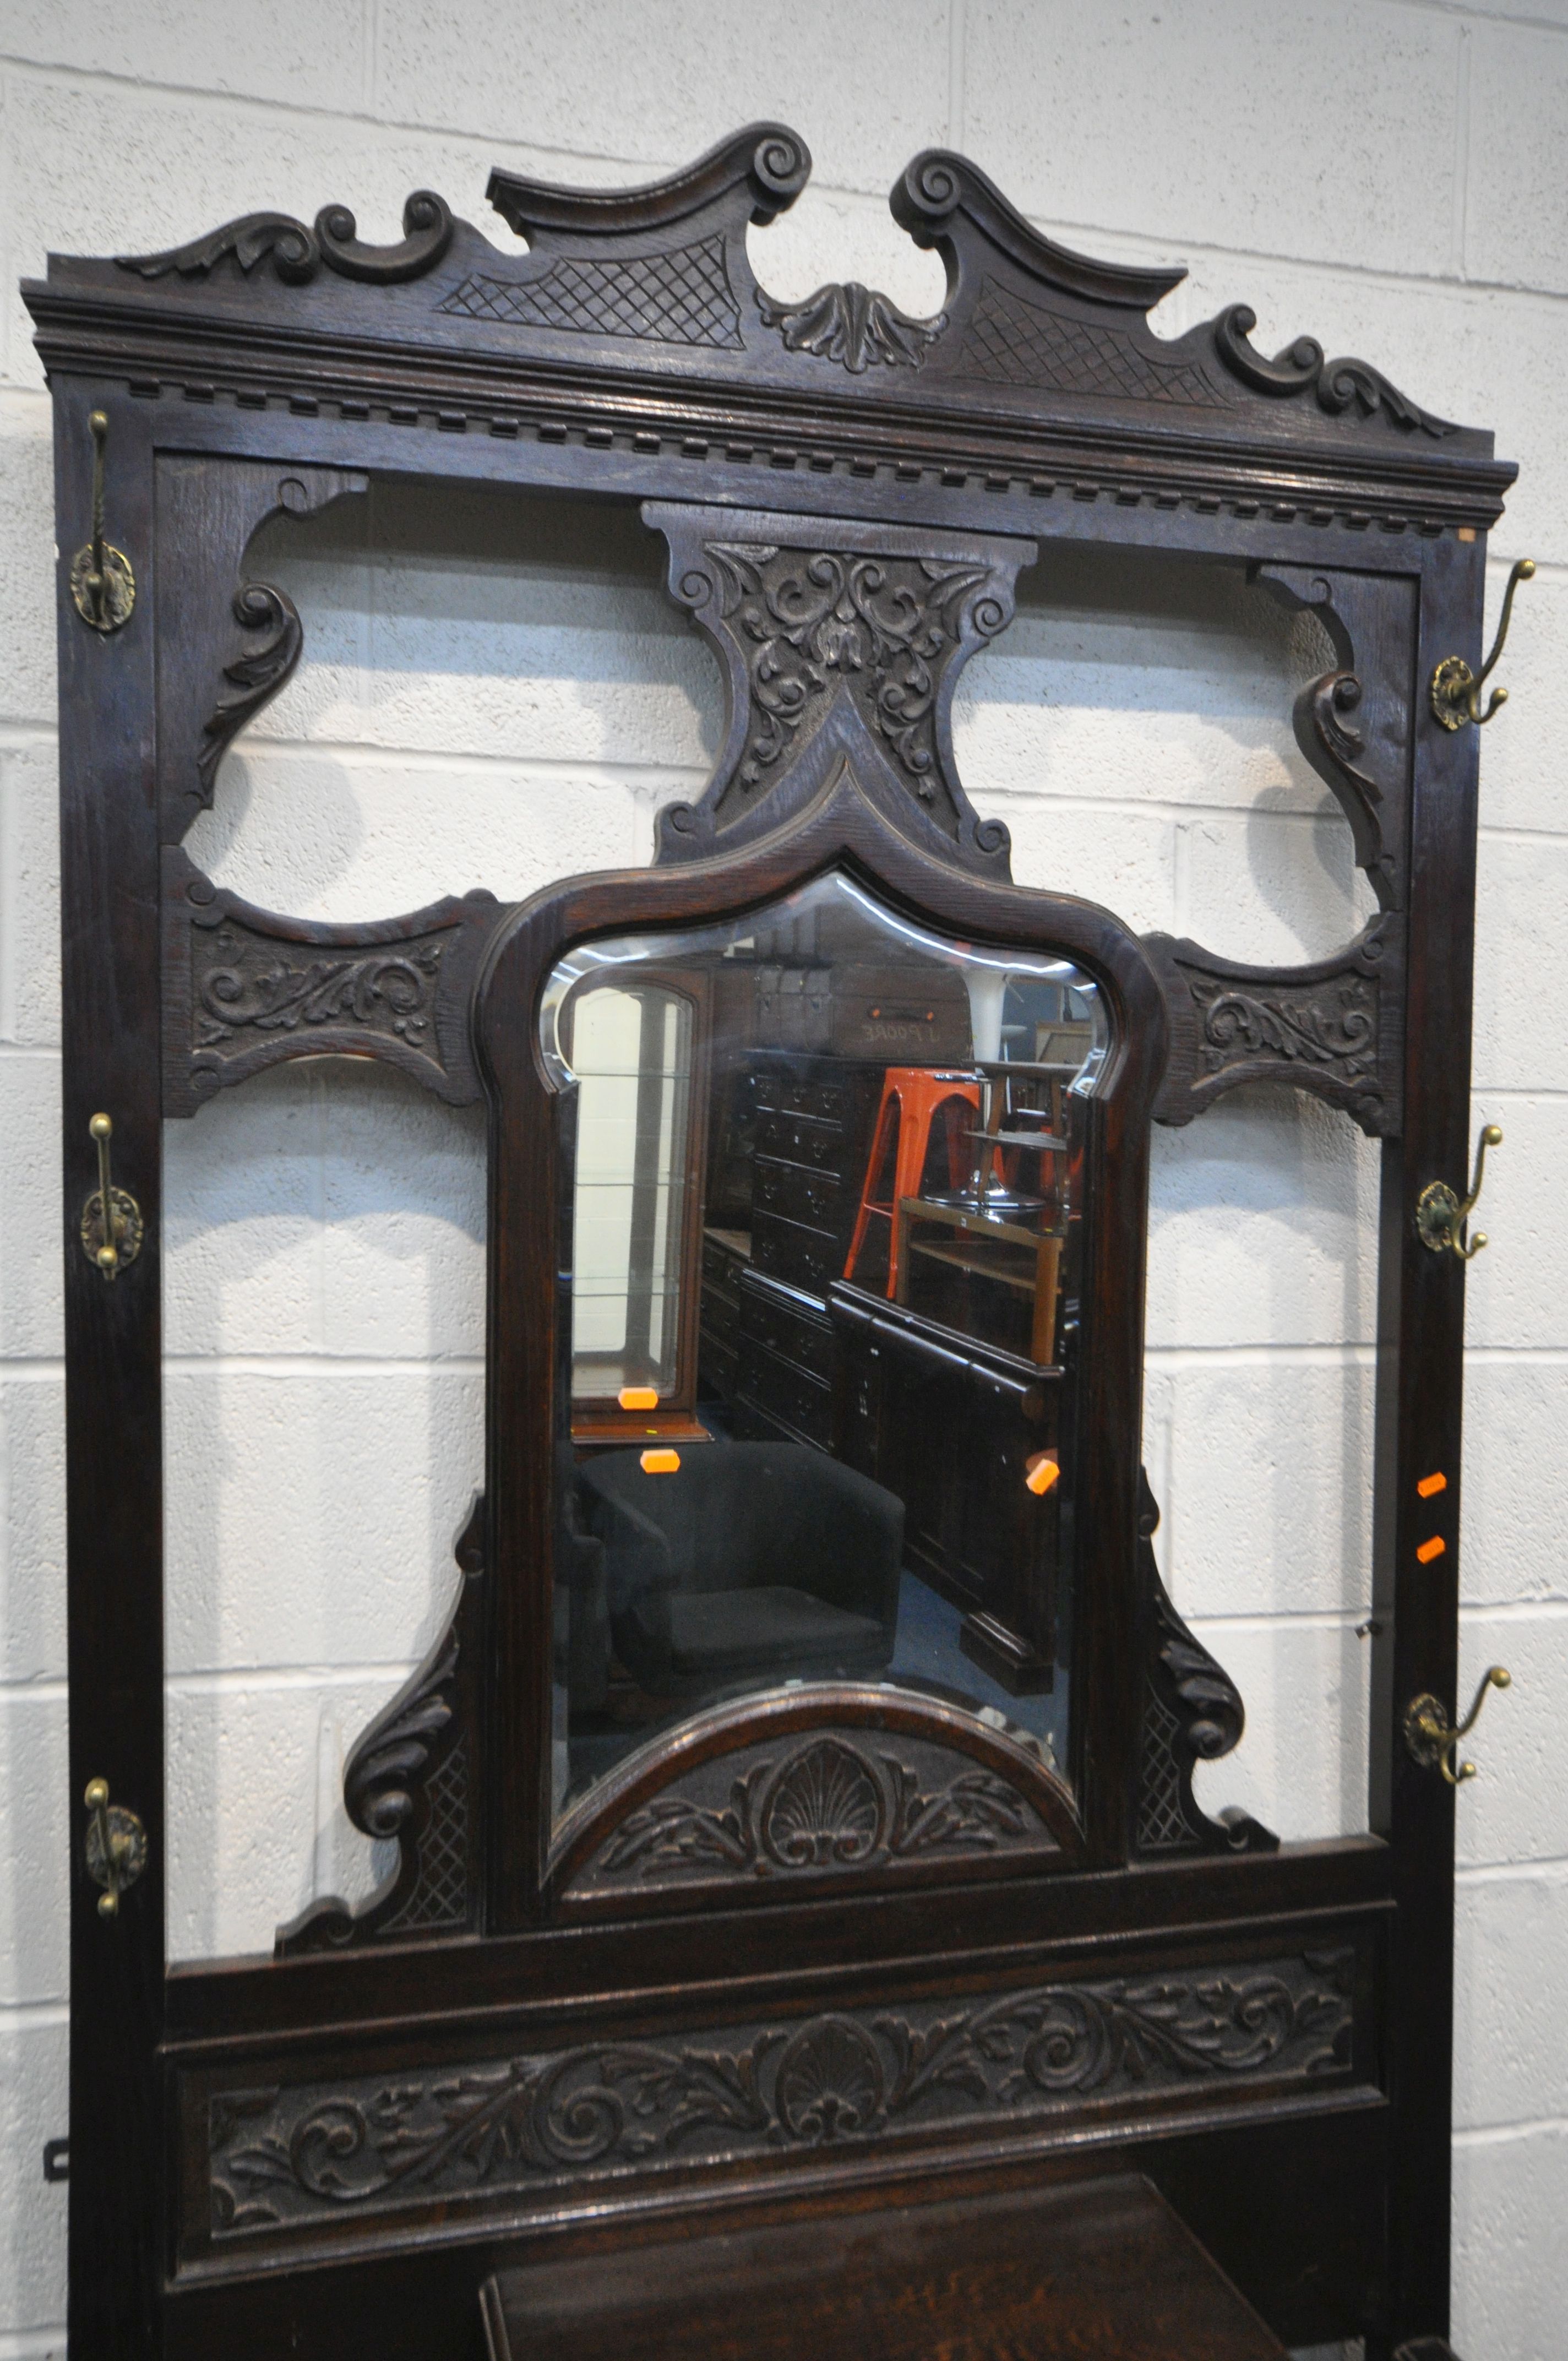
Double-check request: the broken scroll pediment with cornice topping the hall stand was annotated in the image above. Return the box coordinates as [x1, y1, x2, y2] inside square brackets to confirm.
[28, 123, 1506, 531]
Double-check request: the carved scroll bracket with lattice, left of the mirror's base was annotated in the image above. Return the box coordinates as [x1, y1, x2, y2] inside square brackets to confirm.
[274, 1494, 484, 1960]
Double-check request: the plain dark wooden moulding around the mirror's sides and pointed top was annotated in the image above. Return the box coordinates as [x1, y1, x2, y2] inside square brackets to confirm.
[475, 765, 1164, 1929]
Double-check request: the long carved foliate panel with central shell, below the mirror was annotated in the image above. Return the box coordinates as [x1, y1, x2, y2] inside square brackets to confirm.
[192, 1943, 1367, 2257]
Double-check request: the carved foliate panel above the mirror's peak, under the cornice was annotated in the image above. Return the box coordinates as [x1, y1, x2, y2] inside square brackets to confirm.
[643, 501, 1037, 876]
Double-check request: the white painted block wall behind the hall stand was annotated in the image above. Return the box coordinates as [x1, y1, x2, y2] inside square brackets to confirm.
[0, 0, 1568, 2361]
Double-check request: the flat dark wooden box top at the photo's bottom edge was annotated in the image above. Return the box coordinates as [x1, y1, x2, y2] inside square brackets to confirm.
[484, 2177, 1284, 2361]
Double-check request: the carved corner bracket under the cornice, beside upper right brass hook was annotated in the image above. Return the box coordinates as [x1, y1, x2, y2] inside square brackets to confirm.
[1251, 564, 1414, 909]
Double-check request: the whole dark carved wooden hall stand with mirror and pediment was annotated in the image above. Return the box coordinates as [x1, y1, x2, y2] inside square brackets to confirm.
[26, 125, 1513, 2361]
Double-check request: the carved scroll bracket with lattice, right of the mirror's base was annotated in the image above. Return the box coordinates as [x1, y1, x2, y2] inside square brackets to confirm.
[1134, 1471, 1280, 1858]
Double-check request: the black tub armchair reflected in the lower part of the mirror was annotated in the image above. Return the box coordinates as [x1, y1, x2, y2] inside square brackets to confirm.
[579, 1443, 905, 1695]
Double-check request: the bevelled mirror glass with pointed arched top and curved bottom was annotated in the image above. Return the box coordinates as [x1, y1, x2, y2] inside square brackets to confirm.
[543, 874, 1108, 1809]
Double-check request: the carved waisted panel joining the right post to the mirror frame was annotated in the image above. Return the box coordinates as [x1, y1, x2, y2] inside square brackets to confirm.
[1143, 911, 1405, 1138]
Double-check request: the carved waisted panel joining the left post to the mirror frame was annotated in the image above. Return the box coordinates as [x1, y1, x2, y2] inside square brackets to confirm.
[163, 845, 505, 1114]
